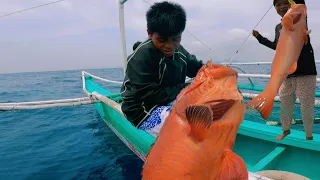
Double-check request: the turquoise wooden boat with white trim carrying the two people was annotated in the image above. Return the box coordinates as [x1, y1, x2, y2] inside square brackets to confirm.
[82, 0, 320, 179]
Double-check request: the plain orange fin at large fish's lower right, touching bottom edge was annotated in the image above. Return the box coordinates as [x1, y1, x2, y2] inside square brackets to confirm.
[216, 149, 249, 180]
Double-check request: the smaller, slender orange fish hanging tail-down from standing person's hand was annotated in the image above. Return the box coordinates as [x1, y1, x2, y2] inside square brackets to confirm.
[247, 0, 311, 120]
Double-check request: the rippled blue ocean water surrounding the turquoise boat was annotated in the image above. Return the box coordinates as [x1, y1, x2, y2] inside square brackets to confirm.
[0, 65, 320, 180]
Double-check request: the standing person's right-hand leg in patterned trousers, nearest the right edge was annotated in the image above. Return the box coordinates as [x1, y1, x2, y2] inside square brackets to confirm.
[297, 76, 316, 140]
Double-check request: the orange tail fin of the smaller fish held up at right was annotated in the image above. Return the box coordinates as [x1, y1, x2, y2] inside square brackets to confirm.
[246, 90, 274, 120]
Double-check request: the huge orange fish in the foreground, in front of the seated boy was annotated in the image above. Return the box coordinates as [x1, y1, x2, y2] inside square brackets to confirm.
[142, 61, 248, 180]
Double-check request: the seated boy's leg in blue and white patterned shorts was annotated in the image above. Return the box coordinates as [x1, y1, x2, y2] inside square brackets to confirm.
[139, 106, 171, 137]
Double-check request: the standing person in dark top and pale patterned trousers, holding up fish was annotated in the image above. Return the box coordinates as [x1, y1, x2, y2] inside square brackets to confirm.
[252, 0, 317, 140]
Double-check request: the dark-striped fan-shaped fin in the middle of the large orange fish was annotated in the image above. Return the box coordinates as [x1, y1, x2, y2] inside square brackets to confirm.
[186, 105, 213, 141]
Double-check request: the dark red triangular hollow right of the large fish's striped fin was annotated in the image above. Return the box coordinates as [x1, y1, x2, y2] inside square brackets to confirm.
[206, 99, 236, 122]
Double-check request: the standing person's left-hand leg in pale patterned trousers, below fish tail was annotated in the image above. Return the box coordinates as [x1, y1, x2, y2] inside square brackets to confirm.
[276, 77, 296, 140]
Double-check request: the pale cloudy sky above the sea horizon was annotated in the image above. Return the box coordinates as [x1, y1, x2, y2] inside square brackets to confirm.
[0, 0, 320, 73]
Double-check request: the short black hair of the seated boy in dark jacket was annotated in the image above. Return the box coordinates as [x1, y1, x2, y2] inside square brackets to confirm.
[146, 1, 187, 37]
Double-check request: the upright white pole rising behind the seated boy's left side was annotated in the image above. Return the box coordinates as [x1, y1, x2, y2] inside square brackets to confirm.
[119, 0, 127, 74]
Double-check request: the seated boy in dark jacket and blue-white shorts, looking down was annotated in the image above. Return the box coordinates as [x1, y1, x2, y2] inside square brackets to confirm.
[121, 1, 203, 137]
